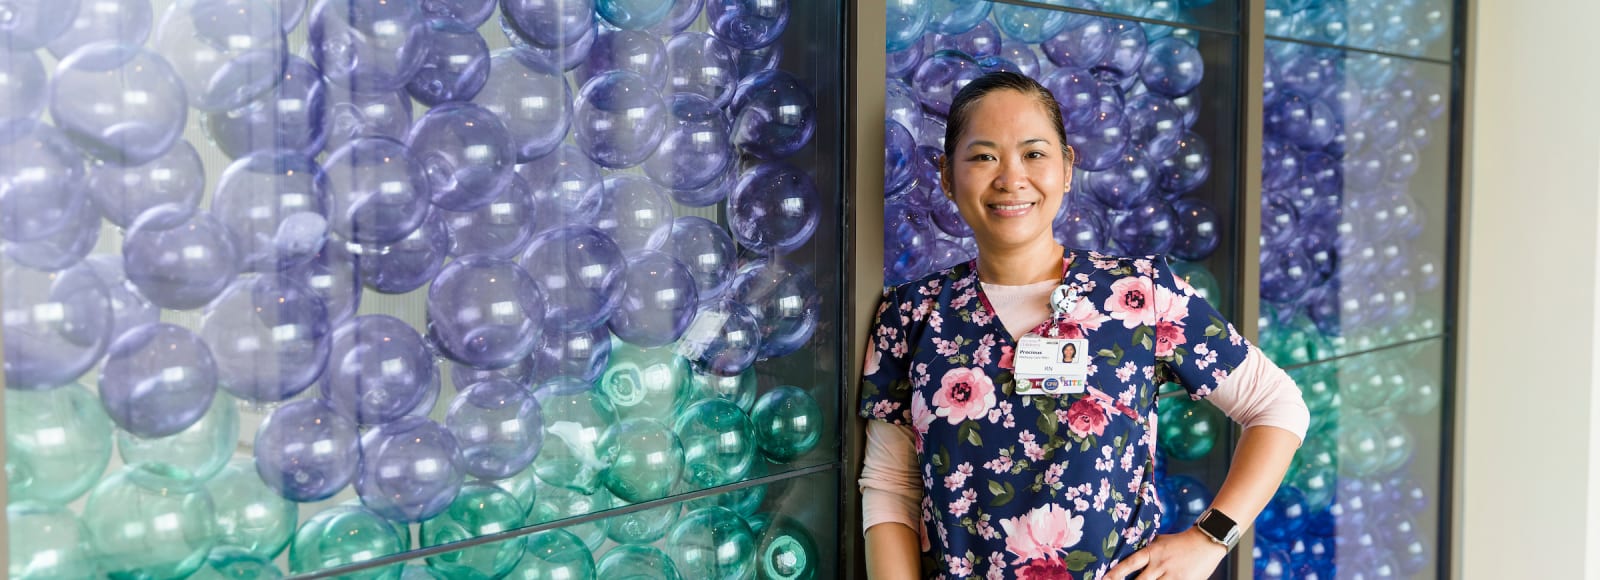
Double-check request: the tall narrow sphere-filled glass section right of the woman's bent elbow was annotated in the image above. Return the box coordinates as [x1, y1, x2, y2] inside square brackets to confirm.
[1254, 0, 1461, 578]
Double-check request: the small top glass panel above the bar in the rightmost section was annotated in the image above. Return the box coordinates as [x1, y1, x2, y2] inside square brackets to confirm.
[1266, 0, 1454, 59]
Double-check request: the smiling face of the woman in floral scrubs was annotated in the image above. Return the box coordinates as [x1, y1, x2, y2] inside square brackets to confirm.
[941, 90, 1072, 252]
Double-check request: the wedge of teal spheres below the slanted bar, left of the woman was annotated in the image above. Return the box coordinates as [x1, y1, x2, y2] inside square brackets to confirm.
[371, 469, 840, 580]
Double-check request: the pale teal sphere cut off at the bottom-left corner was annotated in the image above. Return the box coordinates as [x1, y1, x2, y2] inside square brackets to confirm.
[5, 499, 98, 580]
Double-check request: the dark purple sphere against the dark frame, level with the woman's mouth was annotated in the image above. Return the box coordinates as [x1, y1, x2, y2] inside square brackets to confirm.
[728, 163, 821, 253]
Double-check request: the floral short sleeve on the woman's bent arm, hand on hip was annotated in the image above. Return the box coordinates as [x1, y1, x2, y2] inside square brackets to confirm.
[1155, 258, 1250, 399]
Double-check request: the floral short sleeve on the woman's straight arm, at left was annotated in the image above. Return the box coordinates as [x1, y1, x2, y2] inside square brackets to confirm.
[861, 288, 912, 425]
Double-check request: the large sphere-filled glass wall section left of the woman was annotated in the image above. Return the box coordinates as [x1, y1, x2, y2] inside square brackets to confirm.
[0, 0, 843, 578]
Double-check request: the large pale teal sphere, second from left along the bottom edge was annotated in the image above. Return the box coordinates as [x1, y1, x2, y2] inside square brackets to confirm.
[83, 465, 216, 578]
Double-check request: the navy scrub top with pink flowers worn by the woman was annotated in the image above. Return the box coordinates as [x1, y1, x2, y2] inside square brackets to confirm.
[861, 250, 1250, 578]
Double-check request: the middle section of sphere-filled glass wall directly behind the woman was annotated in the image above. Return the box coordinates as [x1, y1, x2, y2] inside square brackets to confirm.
[869, 0, 1245, 577]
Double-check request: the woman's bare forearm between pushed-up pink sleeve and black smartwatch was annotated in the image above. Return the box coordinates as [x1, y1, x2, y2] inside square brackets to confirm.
[1211, 426, 1301, 530]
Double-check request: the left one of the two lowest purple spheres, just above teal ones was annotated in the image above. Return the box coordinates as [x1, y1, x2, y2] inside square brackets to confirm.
[254, 399, 360, 501]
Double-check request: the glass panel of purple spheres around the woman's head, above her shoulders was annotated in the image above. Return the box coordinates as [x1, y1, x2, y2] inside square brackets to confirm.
[883, 11, 1238, 312]
